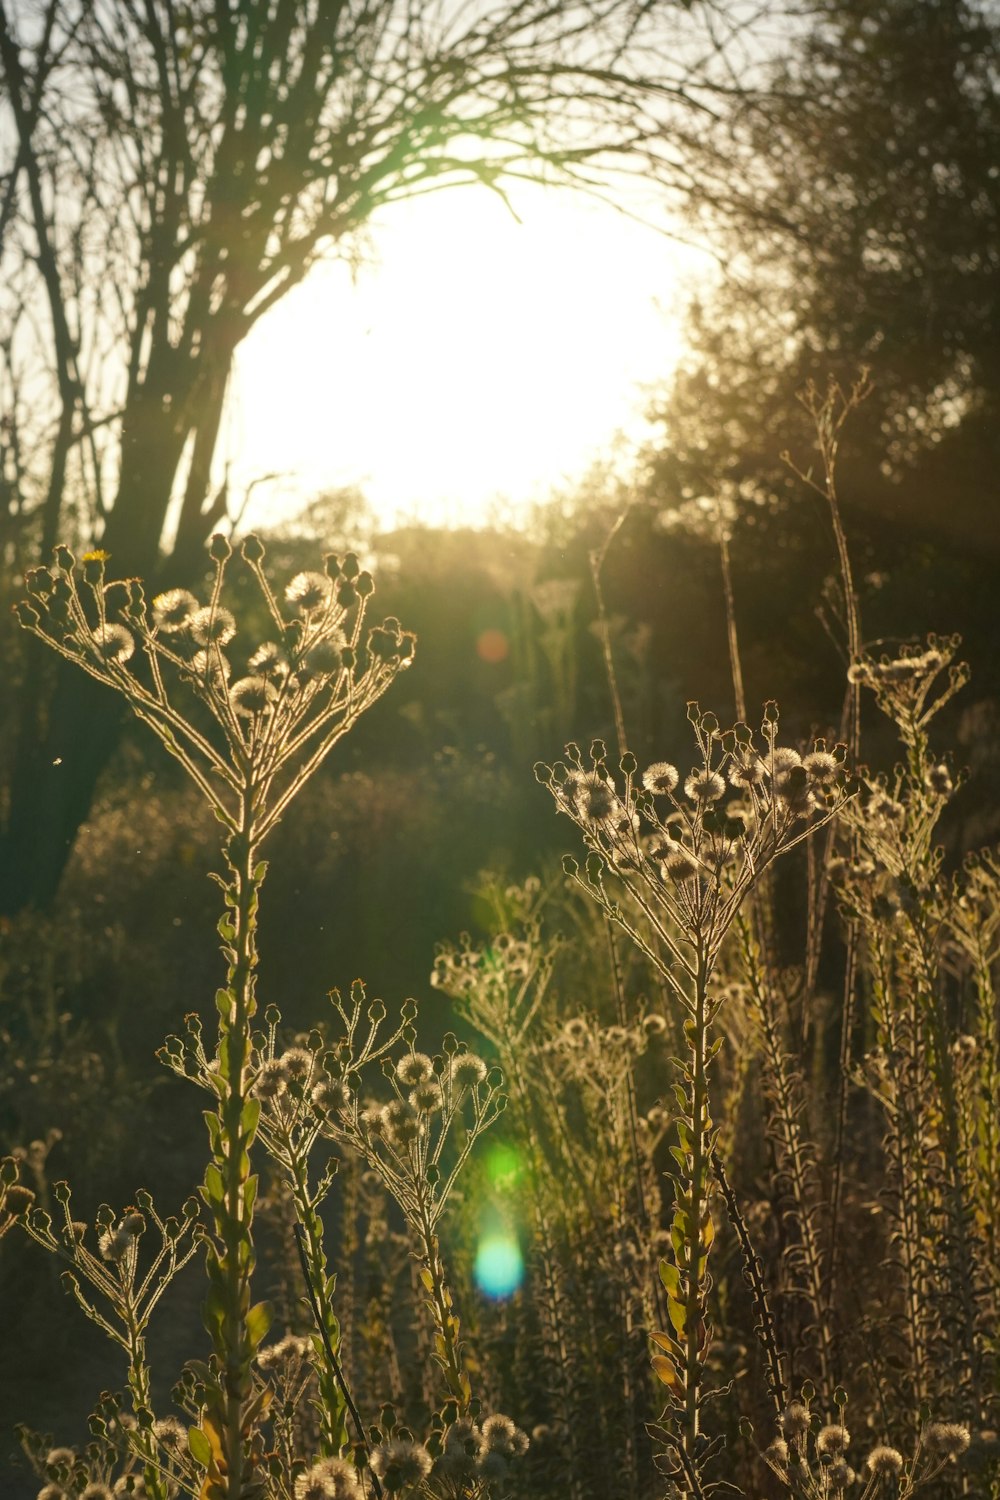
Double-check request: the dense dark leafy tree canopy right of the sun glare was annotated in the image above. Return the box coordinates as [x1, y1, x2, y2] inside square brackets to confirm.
[650, 0, 1000, 543]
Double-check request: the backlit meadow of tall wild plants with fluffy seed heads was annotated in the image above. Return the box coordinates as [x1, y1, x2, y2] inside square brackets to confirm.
[0, 387, 1000, 1500]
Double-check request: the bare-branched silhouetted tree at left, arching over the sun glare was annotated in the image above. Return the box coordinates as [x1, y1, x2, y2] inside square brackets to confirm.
[0, 0, 734, 909]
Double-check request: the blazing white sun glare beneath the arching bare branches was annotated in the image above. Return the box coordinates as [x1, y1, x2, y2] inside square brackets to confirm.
[229, 188, 700, 525]
